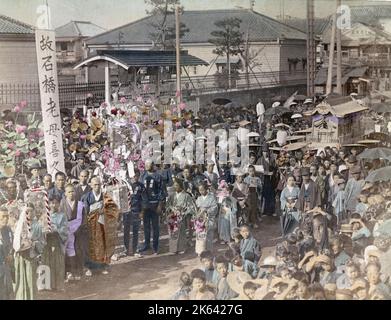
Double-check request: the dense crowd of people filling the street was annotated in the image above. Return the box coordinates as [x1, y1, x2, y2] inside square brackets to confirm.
[0, 95, 391, 300]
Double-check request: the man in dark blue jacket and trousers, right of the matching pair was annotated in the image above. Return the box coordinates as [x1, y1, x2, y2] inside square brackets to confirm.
[140, 161, 166, 255]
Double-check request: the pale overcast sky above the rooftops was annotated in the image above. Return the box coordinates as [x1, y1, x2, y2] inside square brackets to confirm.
[0, 0, 391, 29]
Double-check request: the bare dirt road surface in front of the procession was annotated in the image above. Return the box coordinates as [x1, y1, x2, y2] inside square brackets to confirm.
[38, 217, 280, 300]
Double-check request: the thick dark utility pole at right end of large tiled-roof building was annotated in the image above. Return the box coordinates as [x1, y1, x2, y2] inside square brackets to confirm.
[307, 0, 316, 97]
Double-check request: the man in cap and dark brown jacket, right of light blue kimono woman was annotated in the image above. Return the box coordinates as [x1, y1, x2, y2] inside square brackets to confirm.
[296, 167, 321, 212]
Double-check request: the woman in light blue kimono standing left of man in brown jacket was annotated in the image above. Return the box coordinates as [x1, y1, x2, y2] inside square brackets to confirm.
[280, 176, 300, 236]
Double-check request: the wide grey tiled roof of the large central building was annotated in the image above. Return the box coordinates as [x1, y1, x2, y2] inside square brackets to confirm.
[87, 9, 306, 45]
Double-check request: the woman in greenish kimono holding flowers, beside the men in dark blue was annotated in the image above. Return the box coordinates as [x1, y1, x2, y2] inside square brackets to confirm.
[166, 179, 197, 254]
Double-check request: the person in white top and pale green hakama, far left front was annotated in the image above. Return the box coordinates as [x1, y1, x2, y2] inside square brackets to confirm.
[13, 204, 46, 300]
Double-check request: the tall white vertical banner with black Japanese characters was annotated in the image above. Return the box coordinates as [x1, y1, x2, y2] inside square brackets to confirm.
[35, 29, 65, 177]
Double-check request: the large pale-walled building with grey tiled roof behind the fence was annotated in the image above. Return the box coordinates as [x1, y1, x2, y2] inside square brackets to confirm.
[85, 9, 306, 87]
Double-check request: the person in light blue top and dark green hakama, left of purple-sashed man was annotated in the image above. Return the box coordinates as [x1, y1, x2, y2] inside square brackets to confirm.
[42, 197, 68, 290]
